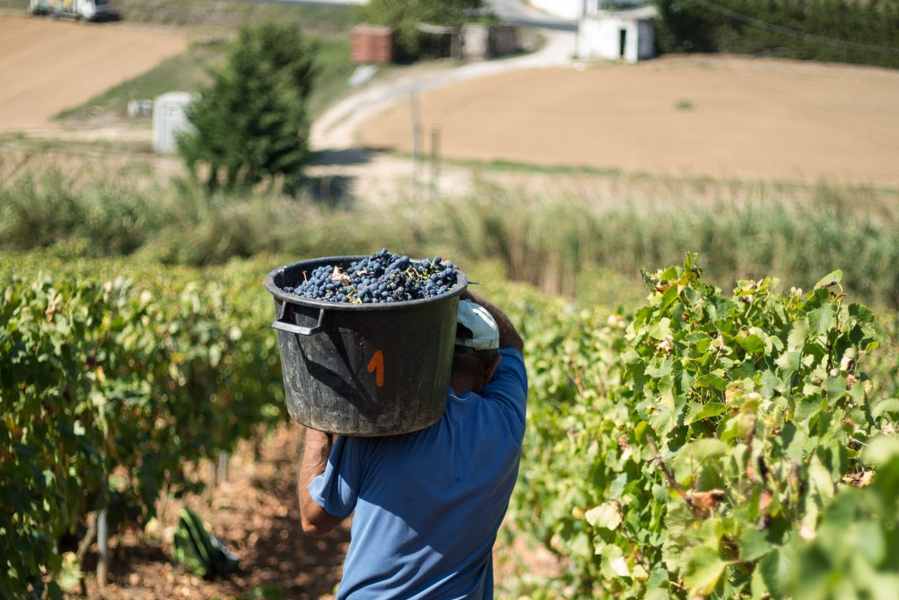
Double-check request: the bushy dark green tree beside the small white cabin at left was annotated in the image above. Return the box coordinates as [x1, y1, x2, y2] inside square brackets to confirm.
[178, 24, 317, 192]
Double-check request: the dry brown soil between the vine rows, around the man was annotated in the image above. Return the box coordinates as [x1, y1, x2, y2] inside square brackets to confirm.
[67, 425, 559, 600]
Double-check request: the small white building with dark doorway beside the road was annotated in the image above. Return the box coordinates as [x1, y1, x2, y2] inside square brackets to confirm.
[577, 0, 658, 63]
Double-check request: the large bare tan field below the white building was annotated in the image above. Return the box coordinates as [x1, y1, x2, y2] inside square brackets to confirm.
[359, 57, 899, 184]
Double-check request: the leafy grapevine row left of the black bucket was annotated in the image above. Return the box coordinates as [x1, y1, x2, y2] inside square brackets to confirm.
[0, 259, 283, 597]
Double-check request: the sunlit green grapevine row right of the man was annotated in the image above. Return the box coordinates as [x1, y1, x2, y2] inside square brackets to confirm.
[512, 259, 899, 598]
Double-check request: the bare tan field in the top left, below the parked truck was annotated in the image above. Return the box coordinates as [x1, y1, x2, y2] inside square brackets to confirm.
[0, 16, 188, 130]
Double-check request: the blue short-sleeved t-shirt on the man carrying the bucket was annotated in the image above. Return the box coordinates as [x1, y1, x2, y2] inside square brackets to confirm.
[309, 348, 527, 600]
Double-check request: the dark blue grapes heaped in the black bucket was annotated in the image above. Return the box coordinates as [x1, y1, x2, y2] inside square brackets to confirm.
[284, 249, 459, 304]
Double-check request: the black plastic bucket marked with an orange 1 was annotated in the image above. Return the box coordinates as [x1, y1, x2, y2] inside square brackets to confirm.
[265, 256, 468, 436]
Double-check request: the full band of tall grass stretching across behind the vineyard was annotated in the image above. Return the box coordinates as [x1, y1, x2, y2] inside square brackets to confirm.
[0, 173, 899, 307]
